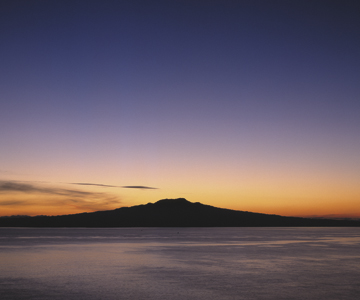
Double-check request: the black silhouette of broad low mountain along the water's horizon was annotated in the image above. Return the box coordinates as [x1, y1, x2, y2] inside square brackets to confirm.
[0, 198, 360, 227]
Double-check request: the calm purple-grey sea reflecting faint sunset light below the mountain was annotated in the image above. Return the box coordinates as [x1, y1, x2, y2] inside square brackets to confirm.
[0, 228, 360, 300]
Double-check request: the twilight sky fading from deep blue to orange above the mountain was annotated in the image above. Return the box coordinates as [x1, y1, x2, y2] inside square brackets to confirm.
[0, 0, 360, 217]
